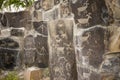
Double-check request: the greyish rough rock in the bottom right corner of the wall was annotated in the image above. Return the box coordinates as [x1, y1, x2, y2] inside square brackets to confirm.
[100, 52, 120, 80]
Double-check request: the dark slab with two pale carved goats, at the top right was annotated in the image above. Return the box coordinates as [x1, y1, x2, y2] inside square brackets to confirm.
[71, 0, 107, 28]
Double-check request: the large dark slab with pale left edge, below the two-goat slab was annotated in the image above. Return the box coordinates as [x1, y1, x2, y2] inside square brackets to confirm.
[75, 26, 106, 80]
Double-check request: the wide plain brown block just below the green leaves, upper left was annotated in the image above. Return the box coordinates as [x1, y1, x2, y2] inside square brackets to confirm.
[4, 11, 31, 28]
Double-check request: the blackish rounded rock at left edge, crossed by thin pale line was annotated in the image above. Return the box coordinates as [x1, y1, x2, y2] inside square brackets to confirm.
[0, 38, 19, 69]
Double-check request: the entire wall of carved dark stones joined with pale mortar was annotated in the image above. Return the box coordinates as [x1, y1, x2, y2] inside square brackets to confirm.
[0, 0, 120, 80]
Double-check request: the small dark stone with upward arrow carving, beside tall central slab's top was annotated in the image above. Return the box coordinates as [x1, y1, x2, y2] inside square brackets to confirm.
[33, 21, 48, 36]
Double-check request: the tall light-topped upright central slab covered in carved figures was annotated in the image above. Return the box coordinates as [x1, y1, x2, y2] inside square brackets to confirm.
[48, 19, 77, 80]
